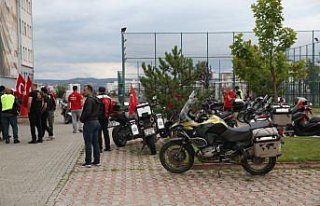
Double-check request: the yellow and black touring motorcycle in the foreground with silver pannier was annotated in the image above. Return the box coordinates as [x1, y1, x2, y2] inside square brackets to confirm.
[159, 91, 281, 175]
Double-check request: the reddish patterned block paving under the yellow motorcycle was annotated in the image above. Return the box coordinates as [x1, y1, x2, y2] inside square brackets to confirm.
[55, 138, 320, 206]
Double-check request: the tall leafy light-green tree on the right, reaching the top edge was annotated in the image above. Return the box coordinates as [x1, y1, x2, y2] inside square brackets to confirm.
[230, 0, 307, 101]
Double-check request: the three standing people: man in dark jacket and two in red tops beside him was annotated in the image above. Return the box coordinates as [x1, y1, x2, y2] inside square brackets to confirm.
[68, 85, 114, 167]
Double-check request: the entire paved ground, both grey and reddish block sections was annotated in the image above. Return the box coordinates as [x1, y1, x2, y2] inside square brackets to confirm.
[0, 115, 320, 206]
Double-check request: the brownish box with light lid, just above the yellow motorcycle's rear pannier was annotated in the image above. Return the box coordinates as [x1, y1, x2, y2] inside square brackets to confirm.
[271, 105, 292, 126]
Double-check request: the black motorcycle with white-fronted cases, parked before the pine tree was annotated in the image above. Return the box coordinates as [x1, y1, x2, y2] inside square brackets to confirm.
[111, 103, 164, 154]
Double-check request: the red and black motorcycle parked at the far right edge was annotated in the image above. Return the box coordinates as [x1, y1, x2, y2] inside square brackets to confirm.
[287, 97, 320, 136]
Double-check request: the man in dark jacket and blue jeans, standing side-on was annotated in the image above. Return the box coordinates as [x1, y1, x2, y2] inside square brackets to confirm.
[80, 85, 100, 167]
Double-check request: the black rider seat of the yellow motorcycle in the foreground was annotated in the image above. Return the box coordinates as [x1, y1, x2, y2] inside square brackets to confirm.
[221, 127, 252, 142]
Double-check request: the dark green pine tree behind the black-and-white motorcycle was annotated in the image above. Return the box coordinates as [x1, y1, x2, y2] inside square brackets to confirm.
[140, 46, 208, 115]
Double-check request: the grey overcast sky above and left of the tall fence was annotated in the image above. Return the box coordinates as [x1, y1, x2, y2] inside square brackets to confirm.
[33, 0, 320, 79]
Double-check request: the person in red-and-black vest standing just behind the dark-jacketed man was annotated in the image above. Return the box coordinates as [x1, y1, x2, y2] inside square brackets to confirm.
[97, 87, 114, 152]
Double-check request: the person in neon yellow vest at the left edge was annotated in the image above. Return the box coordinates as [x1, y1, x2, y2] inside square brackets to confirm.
[1, 88, 20, 144]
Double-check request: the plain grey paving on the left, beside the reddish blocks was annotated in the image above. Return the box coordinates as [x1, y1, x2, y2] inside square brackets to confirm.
[0, 112, 83, 206]
